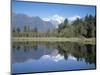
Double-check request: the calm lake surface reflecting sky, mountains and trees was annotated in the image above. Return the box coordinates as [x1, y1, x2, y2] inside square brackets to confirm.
[11, 42, 96, 73]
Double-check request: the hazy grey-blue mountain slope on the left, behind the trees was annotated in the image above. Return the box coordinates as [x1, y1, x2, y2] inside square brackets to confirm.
[12, 13, 56, 32]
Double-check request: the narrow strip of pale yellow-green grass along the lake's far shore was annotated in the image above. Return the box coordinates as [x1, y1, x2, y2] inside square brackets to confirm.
[12, 37, 95, 44]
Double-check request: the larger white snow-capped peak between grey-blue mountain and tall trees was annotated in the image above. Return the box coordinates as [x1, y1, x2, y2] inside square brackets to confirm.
[43, 14, 65, 28]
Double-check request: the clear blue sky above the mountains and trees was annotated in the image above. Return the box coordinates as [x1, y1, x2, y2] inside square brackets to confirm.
[12, 1, 96, 20]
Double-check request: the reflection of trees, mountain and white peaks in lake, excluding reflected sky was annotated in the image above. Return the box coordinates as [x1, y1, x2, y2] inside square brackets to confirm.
[12, 42, 96, 64]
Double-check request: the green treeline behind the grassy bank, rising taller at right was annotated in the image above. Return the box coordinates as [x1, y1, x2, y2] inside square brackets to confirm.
[12, 15, 96, 38]
